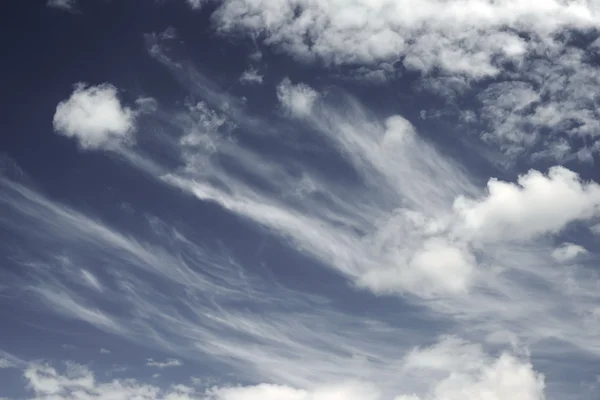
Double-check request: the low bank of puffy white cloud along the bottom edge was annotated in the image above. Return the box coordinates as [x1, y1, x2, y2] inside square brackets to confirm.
[17, 337, 545, 400]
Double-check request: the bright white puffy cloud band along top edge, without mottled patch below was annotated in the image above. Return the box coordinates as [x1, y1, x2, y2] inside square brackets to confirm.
[214, 0, 600, 78]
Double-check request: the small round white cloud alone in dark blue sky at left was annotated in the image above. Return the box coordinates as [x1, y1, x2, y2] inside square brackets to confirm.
[53, 83, 135, 149]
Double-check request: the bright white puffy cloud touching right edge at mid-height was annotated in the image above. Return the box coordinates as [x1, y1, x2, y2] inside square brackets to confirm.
[454, 167, 600, 240]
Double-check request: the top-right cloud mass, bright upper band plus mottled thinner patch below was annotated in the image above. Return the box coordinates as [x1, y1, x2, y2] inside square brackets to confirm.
[177, 0, 600, 159]
